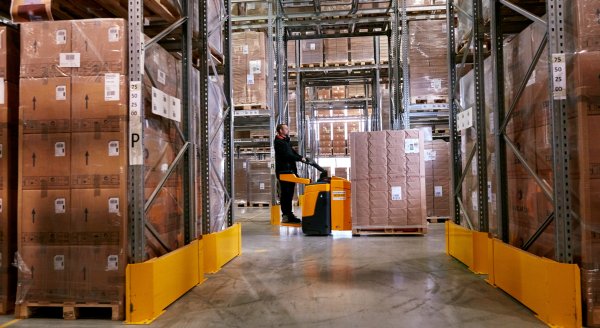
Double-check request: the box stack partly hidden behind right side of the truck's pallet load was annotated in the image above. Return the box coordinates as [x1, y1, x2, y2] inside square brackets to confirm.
[425, 140, 450, 217]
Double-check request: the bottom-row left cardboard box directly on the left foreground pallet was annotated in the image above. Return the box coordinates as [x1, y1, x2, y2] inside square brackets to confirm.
[17, 245, 73, 304]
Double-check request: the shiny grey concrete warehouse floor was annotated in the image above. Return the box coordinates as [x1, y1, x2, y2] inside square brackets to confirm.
[0, 208, 546, 328]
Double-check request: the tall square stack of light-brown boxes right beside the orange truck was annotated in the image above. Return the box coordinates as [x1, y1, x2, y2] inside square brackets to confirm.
[350, 130, 427, 229]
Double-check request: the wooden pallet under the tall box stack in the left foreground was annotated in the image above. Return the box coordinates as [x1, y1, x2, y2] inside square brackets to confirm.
[15, 302, 124, 321]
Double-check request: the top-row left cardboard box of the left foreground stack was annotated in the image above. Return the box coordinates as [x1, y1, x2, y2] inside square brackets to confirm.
[20, 21, 73, 78]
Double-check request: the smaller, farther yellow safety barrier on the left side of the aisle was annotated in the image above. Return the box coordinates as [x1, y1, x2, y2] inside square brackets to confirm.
[202, 223, 242, 273]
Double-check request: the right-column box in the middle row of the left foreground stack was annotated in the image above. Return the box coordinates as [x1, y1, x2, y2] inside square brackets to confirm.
[71, 132, 127, 189]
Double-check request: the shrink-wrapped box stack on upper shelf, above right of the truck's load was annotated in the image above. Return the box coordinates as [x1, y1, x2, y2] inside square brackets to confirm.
[408, 20, 448, 104]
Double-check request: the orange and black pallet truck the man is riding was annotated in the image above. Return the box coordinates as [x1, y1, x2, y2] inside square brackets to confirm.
[279, 158, 352, 236]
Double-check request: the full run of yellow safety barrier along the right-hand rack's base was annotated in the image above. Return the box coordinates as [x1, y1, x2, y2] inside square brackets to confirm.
[446, 222, 582, 327]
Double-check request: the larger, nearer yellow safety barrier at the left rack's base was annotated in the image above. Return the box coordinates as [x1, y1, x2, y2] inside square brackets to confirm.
[126, 240, 204, 324]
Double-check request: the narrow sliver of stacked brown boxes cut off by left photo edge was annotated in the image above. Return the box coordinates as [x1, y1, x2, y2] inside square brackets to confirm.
[0, 26, 19, 314]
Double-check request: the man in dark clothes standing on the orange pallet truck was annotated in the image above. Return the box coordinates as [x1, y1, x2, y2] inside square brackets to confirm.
[274, 124, 306, 223]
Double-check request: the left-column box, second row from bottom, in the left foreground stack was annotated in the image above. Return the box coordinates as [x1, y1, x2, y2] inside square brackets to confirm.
[19, 189, 71, 237]
